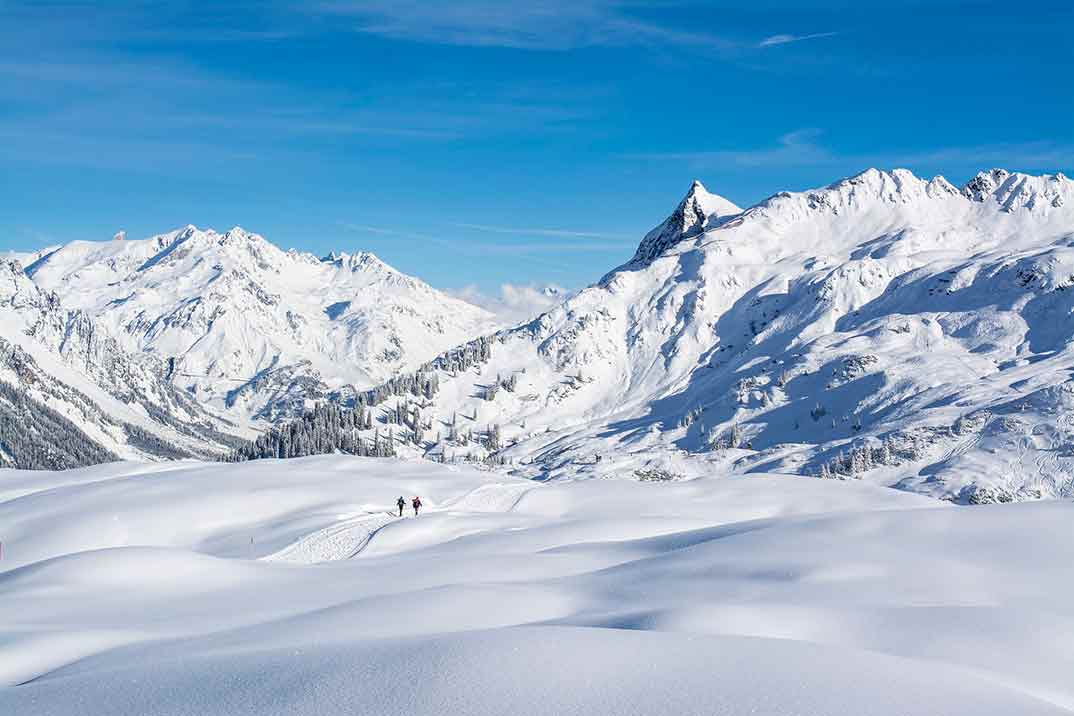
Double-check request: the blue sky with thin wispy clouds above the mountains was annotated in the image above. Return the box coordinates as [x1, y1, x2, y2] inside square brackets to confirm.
[0, 0, 1074, 293]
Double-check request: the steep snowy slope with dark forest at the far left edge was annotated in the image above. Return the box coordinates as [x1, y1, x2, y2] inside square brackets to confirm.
[0, 261, 248, 468]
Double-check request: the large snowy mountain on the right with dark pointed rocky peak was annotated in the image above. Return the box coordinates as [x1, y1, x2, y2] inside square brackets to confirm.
[259, 170, 1074, 501]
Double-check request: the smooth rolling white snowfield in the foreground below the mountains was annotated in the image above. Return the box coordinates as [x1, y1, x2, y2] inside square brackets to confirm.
[0, 455, 1074, 716]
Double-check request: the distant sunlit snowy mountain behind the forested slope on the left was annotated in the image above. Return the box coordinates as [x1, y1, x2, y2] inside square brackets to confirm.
[27, 227, 493, 420]
